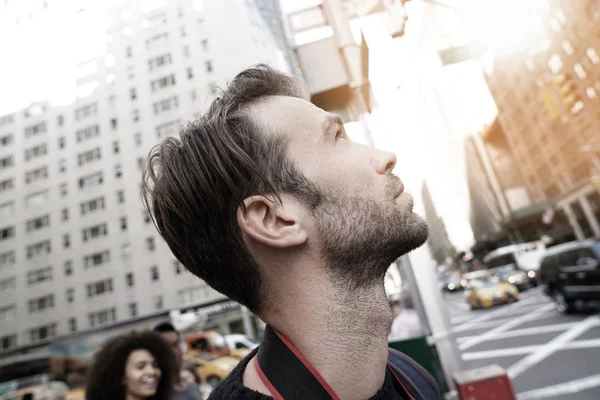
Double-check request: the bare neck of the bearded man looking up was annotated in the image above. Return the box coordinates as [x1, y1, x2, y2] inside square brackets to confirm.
[244, 281, 392, 400]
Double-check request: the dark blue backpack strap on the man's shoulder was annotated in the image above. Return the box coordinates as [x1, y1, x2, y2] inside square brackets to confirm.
[388, 349, 442, 400]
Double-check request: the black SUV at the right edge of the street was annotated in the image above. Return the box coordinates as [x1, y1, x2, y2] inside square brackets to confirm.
[540, 239, 600, 313]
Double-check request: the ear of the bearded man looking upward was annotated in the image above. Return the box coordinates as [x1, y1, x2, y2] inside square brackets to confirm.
[237, 196, 308, 248]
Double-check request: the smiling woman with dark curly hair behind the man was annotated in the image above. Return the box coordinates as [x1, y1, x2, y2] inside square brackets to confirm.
[85, 332, 175, 400]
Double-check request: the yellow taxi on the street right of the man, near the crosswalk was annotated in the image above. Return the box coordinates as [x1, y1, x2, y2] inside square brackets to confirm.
[465, 278, 519, 310]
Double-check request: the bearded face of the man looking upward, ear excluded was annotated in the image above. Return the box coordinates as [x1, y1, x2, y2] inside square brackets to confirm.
[255, 96, 428, 287]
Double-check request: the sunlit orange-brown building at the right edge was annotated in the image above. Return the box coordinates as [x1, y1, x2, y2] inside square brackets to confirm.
[486, 0, 600, 239]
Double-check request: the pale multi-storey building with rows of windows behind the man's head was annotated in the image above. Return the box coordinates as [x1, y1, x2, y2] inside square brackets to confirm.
[0, 0, 289, 355]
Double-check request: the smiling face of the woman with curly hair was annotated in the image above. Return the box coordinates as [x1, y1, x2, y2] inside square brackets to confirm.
[124, 349, 161, 399]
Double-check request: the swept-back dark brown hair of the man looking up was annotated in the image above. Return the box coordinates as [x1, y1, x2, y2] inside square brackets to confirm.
[142, 65, 319, 312]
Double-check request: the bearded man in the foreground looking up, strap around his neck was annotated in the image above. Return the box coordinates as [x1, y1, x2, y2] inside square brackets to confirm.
[143, 65, 439, 400]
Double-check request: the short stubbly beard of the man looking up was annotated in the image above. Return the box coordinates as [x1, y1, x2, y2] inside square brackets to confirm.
[313, 182, 429, 290]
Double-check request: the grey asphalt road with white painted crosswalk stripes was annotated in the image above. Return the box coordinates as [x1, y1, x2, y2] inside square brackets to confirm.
[444, 289, 600, 400]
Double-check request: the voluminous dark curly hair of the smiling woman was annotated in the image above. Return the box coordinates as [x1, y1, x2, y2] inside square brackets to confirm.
[85, 332, 178, 400]
